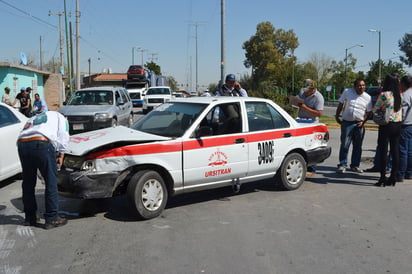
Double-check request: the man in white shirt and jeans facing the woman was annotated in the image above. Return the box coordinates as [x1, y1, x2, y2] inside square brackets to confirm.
[335, 79, 372, 173]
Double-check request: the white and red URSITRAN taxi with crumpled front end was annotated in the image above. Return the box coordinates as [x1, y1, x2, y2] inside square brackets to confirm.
[59, 97, 331, 219]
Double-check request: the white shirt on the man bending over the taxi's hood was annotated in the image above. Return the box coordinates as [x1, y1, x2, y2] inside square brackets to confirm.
[18, 111, 70, 153]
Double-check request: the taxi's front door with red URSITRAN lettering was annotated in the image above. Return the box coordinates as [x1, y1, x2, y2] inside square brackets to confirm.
[183, 103, 248, 188]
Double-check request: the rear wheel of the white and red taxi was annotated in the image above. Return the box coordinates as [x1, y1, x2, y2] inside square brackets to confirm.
[276, 153, 306, 190]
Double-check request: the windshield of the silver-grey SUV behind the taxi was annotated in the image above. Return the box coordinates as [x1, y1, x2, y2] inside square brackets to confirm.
[67, 90, 113, 105]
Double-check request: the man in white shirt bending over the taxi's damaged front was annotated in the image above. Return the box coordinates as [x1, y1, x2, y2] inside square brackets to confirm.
[17, 111, 69, 229]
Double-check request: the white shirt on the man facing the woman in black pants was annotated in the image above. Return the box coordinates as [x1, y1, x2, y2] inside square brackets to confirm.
[339, 88, 372, 122]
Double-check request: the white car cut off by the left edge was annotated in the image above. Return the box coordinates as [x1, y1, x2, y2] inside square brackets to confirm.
[0, 103, 28, 181]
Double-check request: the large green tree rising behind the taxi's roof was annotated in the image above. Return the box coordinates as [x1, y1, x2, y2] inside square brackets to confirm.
[243, 22, 299, 88]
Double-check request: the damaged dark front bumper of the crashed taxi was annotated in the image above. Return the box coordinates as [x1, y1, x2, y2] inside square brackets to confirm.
[58, 170, 119, 199]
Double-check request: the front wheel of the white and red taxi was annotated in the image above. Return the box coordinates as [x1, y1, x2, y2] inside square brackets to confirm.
[127, 170, 168, 220]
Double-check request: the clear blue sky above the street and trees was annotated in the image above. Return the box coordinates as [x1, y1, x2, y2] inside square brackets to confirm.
[0, 0, 412, 90]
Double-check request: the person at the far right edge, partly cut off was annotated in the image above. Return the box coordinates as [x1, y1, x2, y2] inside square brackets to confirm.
[397, 76, 412, 182]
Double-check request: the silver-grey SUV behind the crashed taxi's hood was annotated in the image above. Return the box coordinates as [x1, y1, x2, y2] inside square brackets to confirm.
[59, 87, 133, 134]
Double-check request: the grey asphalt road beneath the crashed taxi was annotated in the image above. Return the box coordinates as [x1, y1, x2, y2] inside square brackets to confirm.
[0, 119, 412, 274]
